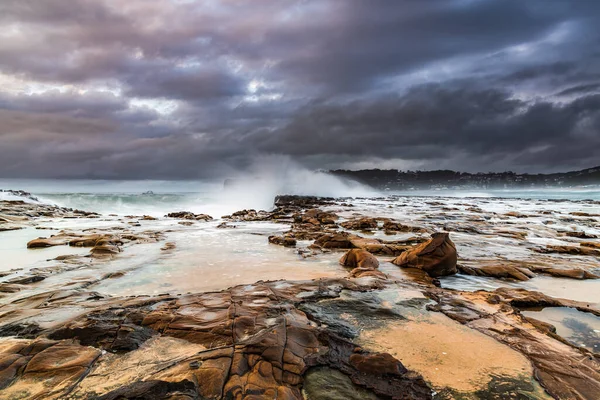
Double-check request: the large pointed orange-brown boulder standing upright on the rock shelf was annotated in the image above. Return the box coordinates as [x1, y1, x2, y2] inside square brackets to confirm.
[392, 232, 457, 277]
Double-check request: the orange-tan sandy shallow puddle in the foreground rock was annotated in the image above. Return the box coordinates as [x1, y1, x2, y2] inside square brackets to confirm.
[359, 312, 548, 399]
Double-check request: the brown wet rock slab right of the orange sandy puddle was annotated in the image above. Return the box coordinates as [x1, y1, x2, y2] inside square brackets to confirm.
[429, 288, 600, 399]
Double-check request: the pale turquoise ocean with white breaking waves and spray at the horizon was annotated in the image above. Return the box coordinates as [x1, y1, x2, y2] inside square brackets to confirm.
[0, 177, 600, 216]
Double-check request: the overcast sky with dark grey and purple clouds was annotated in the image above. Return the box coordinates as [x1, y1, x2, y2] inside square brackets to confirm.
[0, 0, 600, 179]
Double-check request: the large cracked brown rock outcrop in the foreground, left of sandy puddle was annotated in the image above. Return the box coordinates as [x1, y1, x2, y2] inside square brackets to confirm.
[0, 279, 432, 400]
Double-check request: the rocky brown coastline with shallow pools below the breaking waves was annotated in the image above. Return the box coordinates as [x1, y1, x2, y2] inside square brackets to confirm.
[0, 191, 600, 399]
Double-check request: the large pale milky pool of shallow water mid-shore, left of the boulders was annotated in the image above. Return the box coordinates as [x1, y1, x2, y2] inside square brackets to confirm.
[94, 223, 347, 295]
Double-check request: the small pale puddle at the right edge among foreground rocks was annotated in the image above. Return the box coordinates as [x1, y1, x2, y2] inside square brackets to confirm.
[521, 307, 600, 353]
